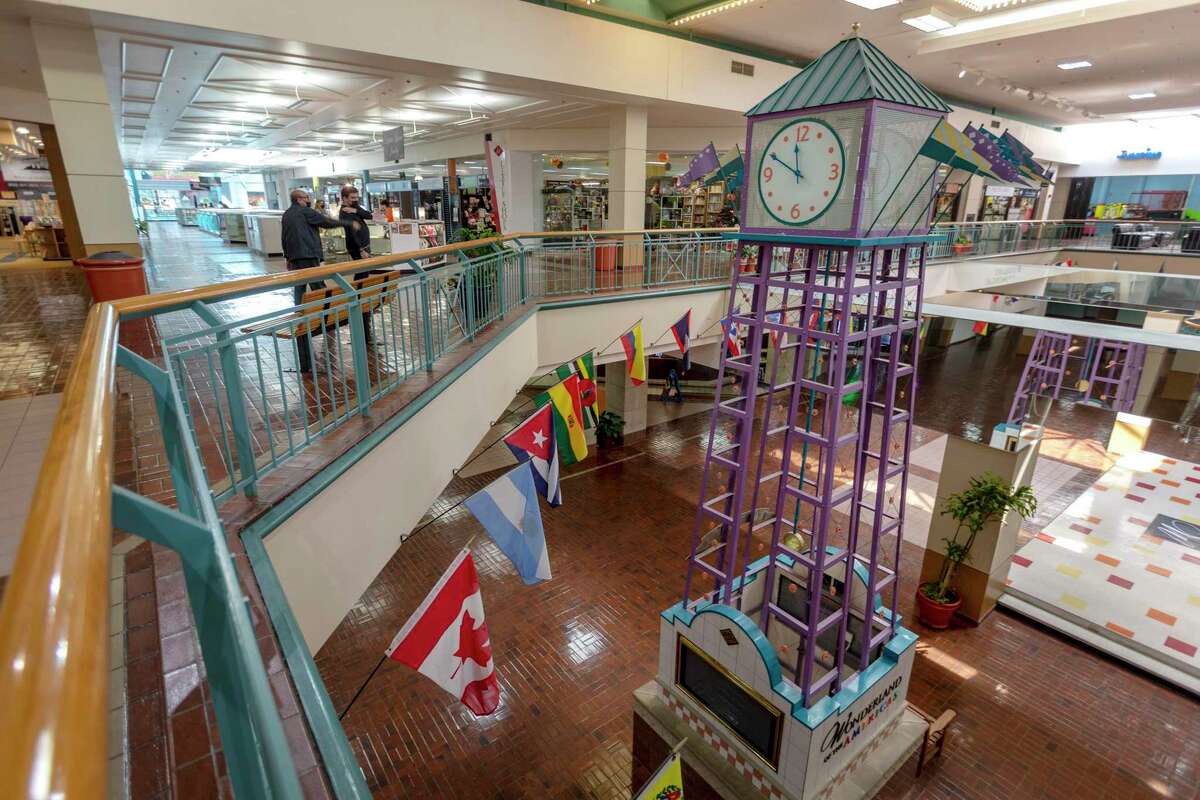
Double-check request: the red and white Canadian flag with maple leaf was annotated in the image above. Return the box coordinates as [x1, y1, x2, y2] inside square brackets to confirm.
[388, 548, 500, 716]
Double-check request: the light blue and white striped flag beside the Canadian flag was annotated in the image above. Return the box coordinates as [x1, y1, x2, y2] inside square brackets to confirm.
[466, 463, 550, 584]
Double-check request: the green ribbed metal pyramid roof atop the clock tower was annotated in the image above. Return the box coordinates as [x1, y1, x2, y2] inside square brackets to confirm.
[746, 36, 950, 116]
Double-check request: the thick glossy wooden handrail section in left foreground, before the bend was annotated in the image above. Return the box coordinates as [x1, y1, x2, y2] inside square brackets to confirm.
[0, 303, 118, 799]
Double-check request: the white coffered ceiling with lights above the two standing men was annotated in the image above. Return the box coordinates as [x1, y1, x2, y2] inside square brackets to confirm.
[96, 30, 633, 169]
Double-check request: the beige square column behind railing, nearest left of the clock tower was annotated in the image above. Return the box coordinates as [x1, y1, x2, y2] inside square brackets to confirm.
[606, 106, 646, 271]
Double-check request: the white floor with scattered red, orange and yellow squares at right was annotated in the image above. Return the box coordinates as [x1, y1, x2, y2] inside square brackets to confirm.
[1009, 452, 1200, 675]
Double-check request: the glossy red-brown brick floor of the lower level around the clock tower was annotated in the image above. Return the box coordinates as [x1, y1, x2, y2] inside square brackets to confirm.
[317, 400, 1200, 800]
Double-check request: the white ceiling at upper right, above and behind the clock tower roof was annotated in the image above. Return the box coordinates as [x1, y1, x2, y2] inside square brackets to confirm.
[681, 0, 1200, 124]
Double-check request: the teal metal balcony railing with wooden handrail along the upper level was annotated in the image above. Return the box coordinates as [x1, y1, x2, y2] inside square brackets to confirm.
[0, 221, 1178, 798]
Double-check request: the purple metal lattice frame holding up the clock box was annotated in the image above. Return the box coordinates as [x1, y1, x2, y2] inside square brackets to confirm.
[684, 234, 925, 705]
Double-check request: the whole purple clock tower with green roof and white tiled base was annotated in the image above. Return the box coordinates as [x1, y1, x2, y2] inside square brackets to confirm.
[635, 30, 949, 799]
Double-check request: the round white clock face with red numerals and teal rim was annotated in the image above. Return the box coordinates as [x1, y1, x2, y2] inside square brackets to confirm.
[756, 116, 846, 225]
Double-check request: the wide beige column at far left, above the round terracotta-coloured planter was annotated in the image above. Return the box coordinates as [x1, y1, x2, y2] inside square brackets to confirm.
[30, 20, 142, 258]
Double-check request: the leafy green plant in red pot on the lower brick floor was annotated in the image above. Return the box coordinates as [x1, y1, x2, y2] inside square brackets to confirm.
[917, 473, 1038, 628]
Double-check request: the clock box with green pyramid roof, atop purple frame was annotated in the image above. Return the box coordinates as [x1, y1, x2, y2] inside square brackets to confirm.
[742, 36, 950, 237]
